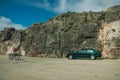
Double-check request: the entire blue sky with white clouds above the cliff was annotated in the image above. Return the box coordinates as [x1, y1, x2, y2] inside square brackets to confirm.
[0, 0, 120, 30]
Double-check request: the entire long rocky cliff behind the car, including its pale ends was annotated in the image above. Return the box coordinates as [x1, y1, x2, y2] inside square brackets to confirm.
[0, 6, 120, 58]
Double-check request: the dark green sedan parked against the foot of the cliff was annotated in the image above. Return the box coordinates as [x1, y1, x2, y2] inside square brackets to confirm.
[66, 49, 101, 60]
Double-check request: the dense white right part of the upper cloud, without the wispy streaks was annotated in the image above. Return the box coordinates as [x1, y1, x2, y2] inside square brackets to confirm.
[54, 0, 120, 13]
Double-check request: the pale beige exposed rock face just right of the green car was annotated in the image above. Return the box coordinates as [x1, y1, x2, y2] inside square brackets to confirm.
[99, 20, 120, 58]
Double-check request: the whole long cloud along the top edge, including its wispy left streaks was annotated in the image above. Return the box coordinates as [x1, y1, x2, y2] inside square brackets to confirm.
[23, 0, 120, 13]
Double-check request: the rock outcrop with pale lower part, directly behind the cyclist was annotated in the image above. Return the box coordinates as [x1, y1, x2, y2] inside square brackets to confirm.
[0, 28, 25, 55]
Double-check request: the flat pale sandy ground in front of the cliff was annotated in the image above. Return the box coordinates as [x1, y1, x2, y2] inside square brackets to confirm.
[0, 56, 120, 80]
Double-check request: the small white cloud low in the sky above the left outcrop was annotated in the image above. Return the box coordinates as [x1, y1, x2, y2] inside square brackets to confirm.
[0, 16, 26, 30]
